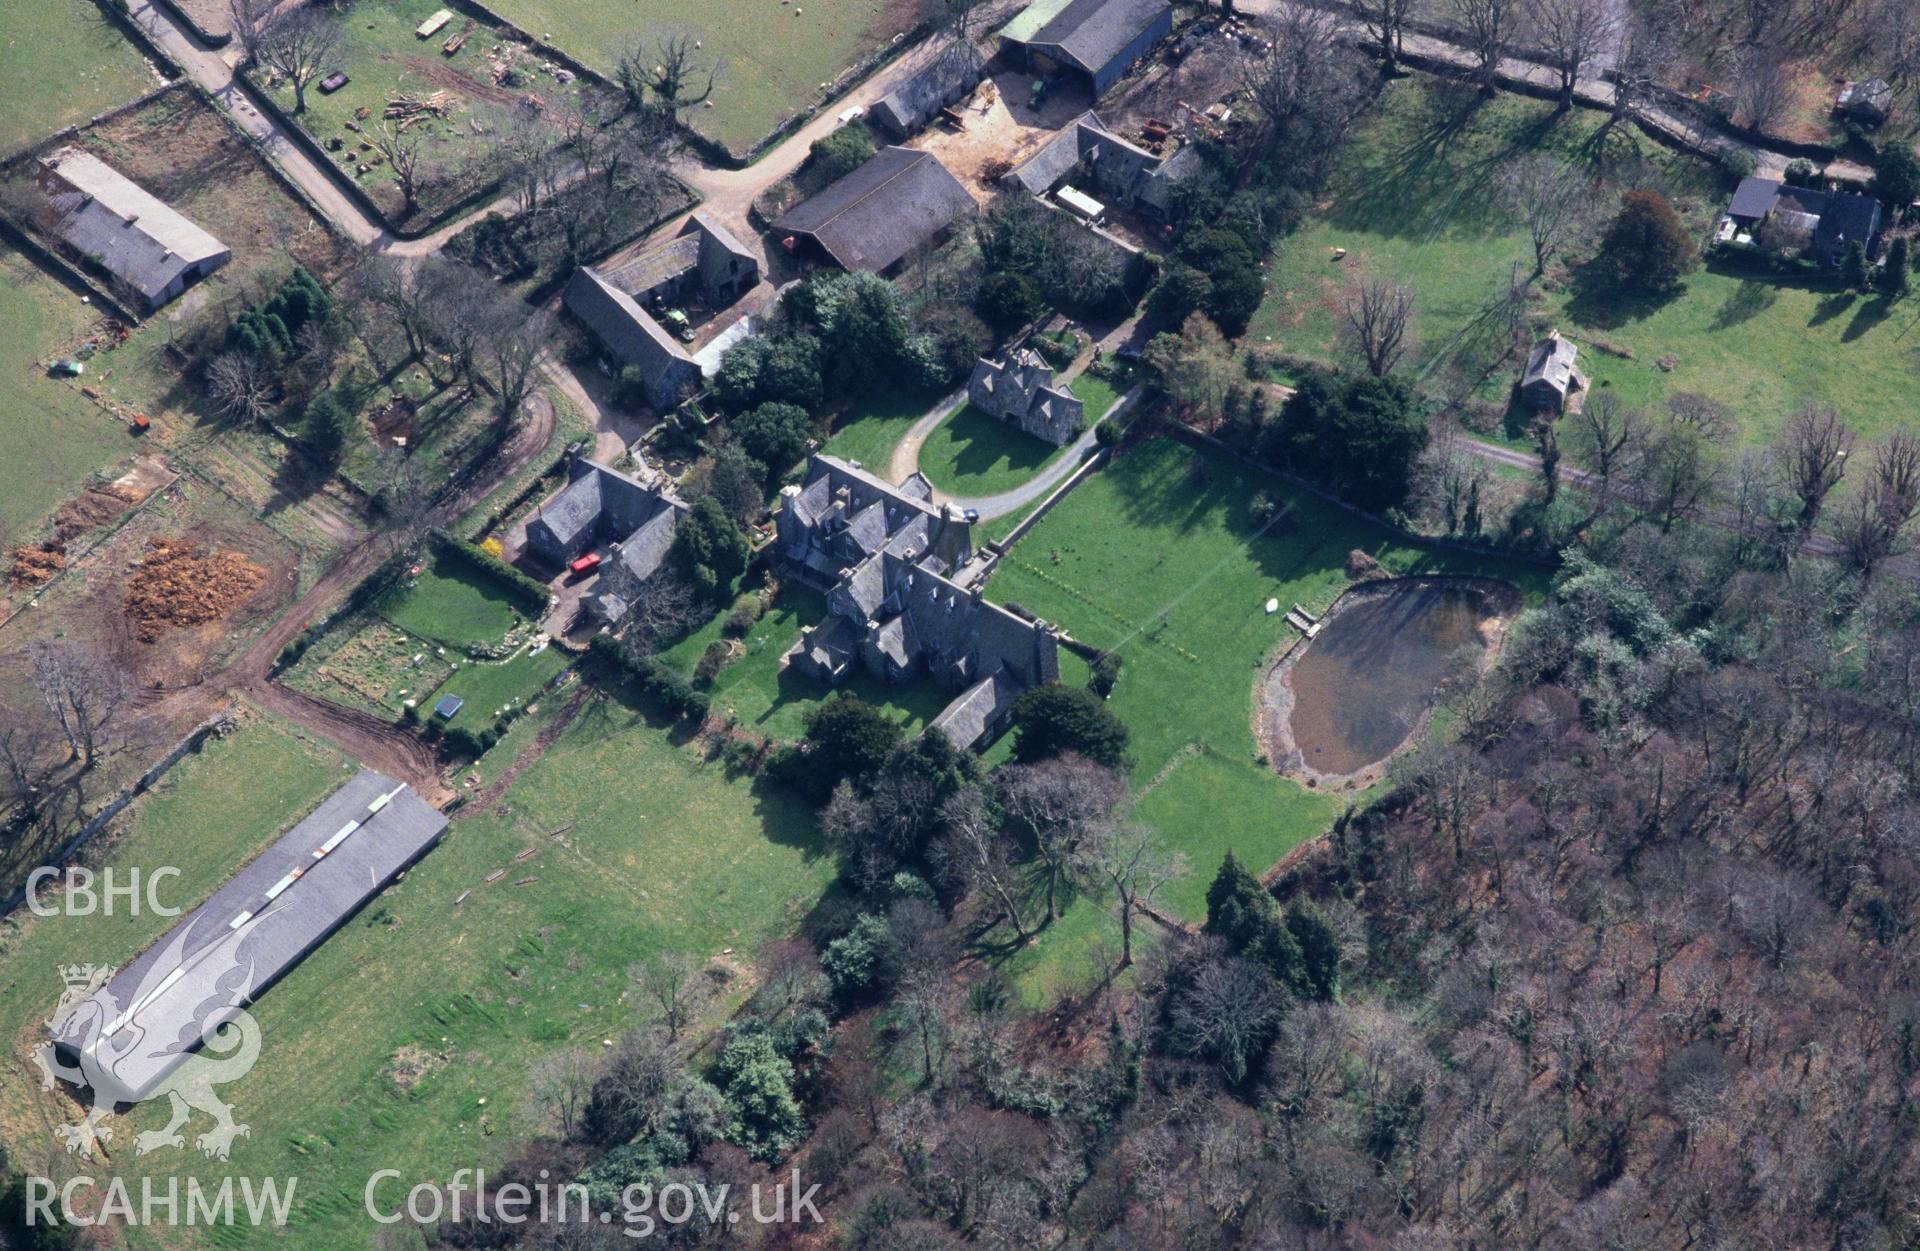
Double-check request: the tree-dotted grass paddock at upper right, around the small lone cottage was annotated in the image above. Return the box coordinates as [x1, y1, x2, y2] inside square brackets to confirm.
[1248, 75, 1920, 441]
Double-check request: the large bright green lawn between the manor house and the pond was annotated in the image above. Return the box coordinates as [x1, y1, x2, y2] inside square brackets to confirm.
[987, 431, 1540, 917]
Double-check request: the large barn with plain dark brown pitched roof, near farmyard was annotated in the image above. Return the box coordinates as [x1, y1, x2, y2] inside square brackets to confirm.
[774, 148, 979, 274]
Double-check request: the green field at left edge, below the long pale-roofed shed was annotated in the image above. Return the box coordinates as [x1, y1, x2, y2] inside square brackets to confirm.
[0, 244, 132, 549]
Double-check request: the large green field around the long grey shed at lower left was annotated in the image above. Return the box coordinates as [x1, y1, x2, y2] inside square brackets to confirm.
[0, 696, 833, 1251]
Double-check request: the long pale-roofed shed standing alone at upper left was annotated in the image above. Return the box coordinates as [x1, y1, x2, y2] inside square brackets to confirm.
[35, 148, 232, 313]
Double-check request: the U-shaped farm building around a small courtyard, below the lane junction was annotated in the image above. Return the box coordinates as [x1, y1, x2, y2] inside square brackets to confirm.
[563, 213, 760, 409]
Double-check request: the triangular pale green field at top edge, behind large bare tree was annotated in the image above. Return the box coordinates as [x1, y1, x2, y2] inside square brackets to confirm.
[495, 0, 922, 152]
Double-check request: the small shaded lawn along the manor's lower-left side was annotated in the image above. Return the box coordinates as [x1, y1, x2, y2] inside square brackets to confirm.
[664, 583, 950, 743]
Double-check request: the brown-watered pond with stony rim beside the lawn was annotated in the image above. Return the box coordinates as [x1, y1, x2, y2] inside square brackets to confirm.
[1263, 579, 1511, 781]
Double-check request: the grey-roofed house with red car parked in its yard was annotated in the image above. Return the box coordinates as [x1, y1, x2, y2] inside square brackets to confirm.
[526, 457, 687, 622]
